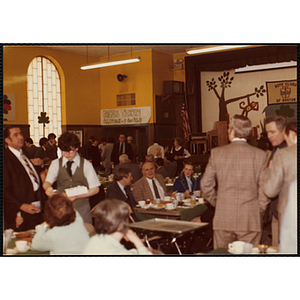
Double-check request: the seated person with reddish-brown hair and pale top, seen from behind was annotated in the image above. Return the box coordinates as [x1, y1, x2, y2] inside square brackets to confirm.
[31, 194, 89, 255]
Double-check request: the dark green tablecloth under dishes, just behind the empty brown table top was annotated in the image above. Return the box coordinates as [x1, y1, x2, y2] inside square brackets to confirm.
[134, 204, 207, 221]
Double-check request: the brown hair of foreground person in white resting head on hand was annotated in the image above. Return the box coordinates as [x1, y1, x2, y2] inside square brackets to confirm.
[92, 199, 129, 234]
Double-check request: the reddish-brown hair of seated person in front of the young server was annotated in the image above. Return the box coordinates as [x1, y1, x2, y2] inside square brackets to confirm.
[44, 194, 76, 228]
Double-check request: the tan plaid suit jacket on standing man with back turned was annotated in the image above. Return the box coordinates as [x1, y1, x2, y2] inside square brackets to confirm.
[201, 141, 269, 232]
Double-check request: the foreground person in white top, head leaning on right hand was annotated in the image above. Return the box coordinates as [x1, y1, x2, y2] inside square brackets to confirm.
[82, 199, 152, 255]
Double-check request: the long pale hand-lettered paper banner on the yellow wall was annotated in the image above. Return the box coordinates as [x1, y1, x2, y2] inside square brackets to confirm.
[101, 106, 151, 125]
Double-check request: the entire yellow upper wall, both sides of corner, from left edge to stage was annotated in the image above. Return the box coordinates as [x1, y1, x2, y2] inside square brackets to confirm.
[3, 46, 188, 125]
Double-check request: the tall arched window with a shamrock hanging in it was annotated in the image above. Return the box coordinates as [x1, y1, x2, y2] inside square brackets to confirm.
[27, 56, 61, 145]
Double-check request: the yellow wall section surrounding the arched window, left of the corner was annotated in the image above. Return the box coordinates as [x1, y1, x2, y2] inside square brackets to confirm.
[3, 46, 100, 125]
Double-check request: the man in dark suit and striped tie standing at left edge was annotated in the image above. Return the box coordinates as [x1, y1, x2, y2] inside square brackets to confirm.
[3, 125, 46, 231]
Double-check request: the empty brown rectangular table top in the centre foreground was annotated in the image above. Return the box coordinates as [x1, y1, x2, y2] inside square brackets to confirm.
[130, 218, 208, 234]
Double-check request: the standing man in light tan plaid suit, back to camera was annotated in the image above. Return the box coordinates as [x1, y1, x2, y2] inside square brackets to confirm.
[201, 115, 269, 249]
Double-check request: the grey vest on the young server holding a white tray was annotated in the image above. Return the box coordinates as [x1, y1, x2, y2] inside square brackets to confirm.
[57, 157, 90, 223]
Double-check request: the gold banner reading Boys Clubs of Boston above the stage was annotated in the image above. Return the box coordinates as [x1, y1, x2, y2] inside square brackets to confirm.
[266, 80, 297, 105]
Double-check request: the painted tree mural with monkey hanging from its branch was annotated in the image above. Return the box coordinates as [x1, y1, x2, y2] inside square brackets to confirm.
[206, 72, 266, 121]
